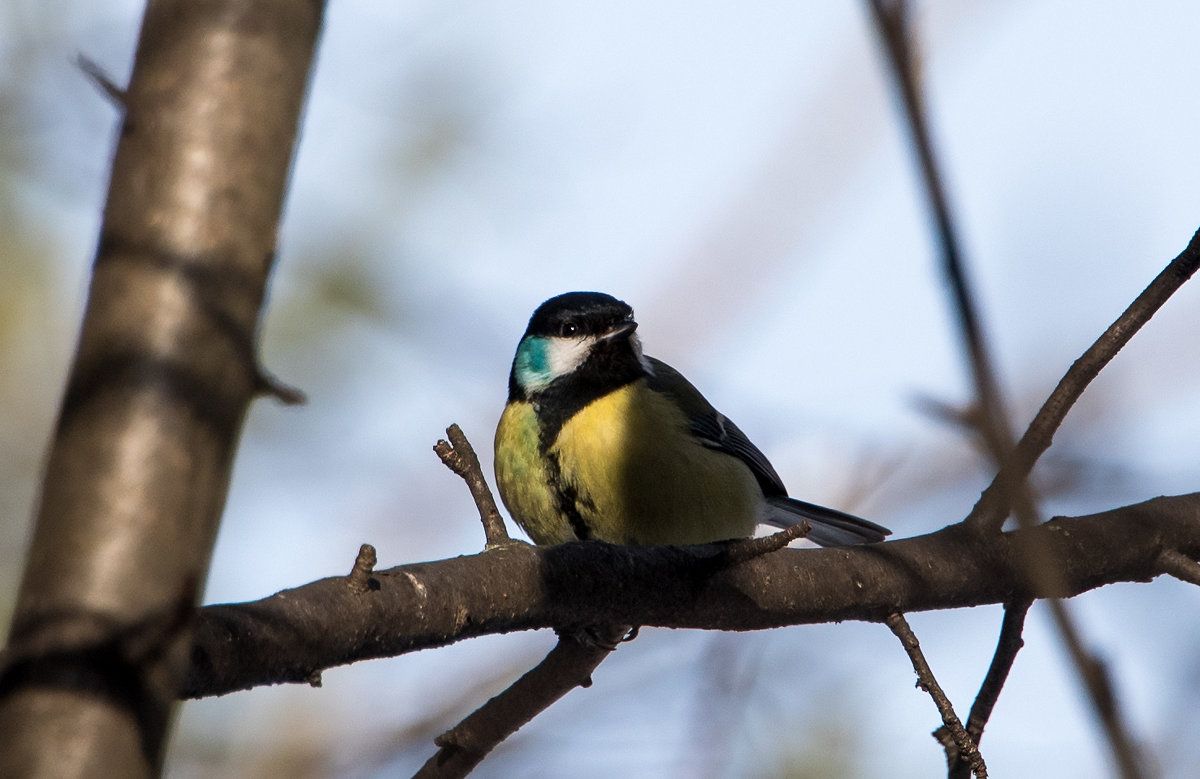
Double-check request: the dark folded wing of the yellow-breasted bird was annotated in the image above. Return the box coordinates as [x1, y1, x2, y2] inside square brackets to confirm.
[646, 356, 787, 497]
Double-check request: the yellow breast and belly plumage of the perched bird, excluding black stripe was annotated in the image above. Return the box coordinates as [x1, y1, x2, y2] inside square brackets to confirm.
[496, 382, 762, 544]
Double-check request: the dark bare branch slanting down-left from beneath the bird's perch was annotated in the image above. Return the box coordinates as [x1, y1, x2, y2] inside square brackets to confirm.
[415, 627, 626, 779]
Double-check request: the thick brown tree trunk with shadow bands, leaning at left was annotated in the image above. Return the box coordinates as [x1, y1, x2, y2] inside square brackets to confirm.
[0, 0, 323, 777]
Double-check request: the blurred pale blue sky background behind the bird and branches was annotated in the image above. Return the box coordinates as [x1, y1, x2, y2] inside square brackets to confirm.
[0, 0, 1200, 778]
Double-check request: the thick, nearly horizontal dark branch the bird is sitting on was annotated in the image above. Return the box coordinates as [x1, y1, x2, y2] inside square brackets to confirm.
[181, 493, 1200, 697]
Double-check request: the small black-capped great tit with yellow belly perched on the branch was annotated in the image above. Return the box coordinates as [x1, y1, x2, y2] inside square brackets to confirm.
[496, 292, 890, 546]
